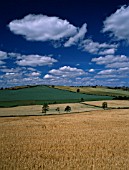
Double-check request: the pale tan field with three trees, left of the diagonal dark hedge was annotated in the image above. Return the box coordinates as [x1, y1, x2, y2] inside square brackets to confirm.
[0, 103, 100, 116]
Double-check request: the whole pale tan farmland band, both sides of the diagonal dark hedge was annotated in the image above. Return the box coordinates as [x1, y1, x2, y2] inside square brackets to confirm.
[0, 100, 129, 117]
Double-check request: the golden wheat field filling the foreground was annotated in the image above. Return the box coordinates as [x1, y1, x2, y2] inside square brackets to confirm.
[0, 109, 129, 170]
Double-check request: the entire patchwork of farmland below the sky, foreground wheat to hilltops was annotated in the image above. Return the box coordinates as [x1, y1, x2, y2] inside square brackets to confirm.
[0, 86, 129, 170]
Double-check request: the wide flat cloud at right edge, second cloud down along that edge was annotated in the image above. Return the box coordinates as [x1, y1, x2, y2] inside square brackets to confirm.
[91, 55, 129, 68]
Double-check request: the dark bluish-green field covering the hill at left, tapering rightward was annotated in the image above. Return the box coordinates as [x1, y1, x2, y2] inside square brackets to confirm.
[0, 86, 112, 107]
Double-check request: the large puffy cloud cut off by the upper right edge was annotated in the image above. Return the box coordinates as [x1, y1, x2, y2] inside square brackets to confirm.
[102, 6, 129, 42]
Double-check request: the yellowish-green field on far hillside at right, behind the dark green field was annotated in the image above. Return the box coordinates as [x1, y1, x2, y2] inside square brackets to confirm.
[55, 86, 129, 97]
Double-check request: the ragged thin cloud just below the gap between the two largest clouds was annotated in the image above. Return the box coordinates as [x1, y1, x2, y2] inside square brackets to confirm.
[79, 39, 118, 55]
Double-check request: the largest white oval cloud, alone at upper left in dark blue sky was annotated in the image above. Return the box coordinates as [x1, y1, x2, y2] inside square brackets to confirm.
[8, 14, 77, 41]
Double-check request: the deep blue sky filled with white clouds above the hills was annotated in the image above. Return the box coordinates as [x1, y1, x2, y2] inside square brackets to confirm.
[0, 0, 129, 87]
